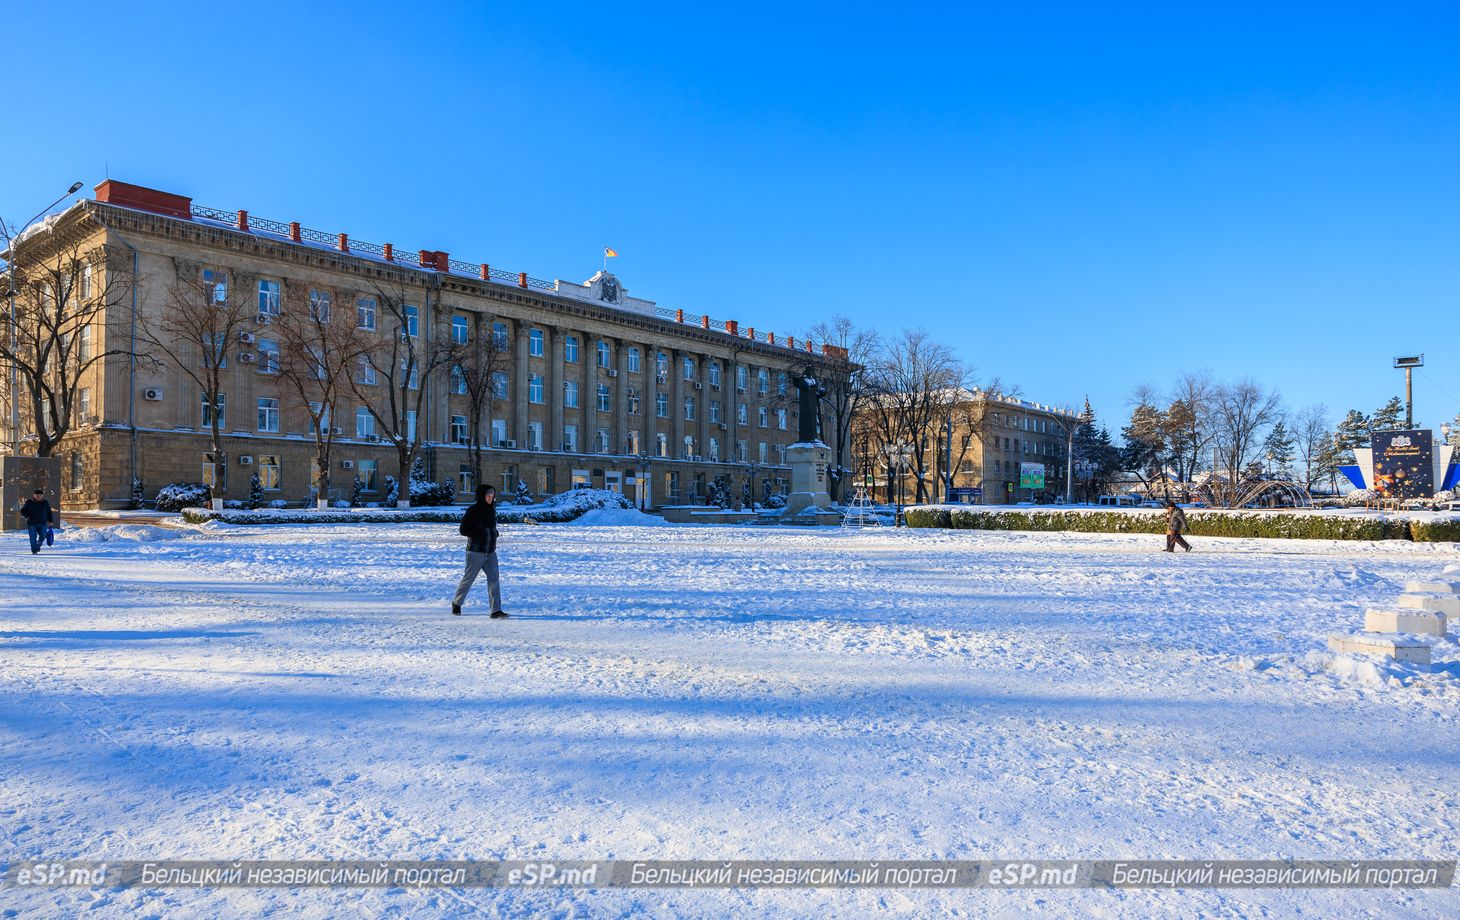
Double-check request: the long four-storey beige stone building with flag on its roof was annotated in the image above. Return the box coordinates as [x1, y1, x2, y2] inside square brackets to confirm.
[7, 180, 844, 507]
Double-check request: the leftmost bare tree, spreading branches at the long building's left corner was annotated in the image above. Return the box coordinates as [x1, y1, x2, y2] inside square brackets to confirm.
[0, 229, 136, 457]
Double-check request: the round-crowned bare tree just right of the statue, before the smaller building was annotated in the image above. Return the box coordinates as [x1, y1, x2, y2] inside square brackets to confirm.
[867, 329, 969, 502]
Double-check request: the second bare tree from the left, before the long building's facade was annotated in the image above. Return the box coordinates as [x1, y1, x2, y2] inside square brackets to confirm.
[137, 260, 258, 499]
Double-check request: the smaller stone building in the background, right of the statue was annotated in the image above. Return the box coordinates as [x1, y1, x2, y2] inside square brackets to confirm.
[853, 390, 1079, 504]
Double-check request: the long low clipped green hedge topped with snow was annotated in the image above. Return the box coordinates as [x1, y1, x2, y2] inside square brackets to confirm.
[907, 508, 1460, 542]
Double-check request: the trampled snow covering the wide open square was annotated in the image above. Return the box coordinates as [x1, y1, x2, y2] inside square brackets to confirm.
[0, 522, 1460, 917]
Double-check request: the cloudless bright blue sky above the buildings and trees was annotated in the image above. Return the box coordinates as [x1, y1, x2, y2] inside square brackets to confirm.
[0, 3, 1460, 428]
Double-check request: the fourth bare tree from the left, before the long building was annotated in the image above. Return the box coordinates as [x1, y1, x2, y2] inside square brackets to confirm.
[347, 279, 451, 508]
